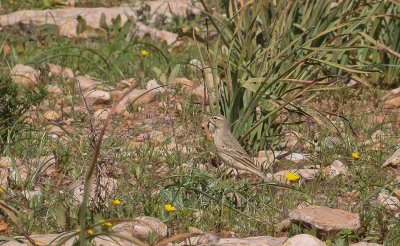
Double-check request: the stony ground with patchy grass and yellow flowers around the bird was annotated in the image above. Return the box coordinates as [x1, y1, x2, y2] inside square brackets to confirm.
[0, 1, 400, 246]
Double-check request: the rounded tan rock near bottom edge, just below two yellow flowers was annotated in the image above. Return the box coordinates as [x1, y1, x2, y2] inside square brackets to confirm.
[112, 216, 168, 240]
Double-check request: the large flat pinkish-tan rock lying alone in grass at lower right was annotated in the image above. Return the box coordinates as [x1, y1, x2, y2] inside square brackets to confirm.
[289, 205, 361, 232]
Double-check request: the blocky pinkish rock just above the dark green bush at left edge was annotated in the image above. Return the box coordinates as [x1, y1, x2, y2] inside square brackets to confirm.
[11, 64, 40, 88]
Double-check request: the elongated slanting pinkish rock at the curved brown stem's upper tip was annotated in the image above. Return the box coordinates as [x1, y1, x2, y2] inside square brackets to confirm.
[115, 89, 156, 114]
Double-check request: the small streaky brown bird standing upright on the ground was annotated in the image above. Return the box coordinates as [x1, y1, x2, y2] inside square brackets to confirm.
[209, 115, 272, 182]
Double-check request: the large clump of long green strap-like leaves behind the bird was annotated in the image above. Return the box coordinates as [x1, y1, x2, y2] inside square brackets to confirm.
[199, 0, 396, 150]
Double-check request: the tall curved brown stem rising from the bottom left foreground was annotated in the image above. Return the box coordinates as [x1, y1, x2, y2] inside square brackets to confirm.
[78, 85, 136, 246]
